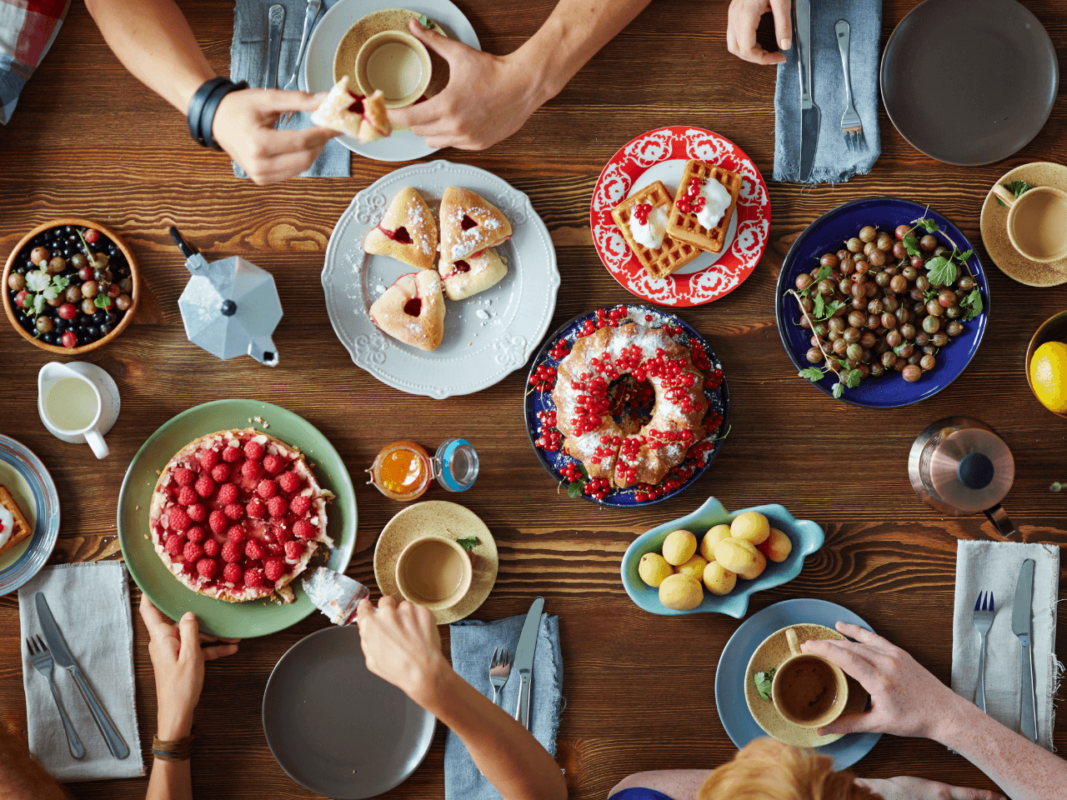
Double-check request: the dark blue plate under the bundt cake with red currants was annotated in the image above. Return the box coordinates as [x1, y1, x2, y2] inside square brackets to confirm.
[523, 305, 730, 508]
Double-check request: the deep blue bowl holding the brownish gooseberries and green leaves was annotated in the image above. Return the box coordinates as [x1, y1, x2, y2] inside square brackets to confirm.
[775, 197, 989, 409]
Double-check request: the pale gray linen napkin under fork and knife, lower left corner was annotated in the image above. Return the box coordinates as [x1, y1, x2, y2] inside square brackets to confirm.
[18, 561, 144, 782]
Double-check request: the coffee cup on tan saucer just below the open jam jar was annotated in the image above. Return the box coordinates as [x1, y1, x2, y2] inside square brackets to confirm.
[396, 535, 474, 611]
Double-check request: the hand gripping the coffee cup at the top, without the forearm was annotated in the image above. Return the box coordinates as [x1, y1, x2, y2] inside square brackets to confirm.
[388, 19, 550, 150]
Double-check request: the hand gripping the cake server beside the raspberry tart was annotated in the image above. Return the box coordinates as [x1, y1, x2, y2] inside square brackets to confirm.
[356, 597, 448, 707]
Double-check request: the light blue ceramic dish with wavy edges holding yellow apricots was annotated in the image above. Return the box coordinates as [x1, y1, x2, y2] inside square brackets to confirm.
[622, 497, 826, 620]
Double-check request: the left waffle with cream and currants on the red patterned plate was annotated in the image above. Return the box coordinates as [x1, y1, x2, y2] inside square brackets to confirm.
[611, 180, 700, 278]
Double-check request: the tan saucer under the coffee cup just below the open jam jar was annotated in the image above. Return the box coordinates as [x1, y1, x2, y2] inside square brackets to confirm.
[375, 500, 500, 625]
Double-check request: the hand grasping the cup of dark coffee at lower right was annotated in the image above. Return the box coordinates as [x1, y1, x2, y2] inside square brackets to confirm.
[800, 622, 958, 738]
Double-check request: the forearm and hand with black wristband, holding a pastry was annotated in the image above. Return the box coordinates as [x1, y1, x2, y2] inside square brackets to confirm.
[85, 0, 337, 183]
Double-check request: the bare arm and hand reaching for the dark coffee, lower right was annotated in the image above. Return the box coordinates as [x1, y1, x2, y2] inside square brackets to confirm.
[801, 622, 1067, 800]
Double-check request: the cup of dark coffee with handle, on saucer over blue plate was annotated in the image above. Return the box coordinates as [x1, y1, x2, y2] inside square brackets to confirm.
[770, 628, 848, 727]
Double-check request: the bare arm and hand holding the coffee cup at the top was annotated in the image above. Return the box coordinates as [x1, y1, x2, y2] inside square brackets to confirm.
[388, 0, 650, 150]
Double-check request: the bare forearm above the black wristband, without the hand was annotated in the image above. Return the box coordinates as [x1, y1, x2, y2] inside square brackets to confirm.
[85, 0, 214, 113]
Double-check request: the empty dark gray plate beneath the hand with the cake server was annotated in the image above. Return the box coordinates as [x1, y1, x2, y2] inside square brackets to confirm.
[262, 625, 436, 800]
